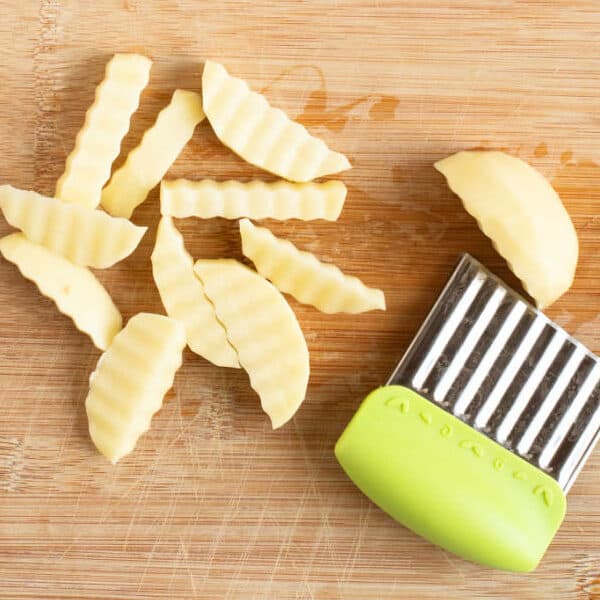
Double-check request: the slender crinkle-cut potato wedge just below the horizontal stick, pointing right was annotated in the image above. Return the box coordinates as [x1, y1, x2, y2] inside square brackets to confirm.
[240, 219, 385, 313]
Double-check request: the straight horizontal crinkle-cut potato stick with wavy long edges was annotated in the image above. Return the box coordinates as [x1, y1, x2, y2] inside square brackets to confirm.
[160, 179, 347, 221]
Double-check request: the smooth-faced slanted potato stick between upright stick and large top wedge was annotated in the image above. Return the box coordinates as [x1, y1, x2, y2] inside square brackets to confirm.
[102, 90, 204, 218]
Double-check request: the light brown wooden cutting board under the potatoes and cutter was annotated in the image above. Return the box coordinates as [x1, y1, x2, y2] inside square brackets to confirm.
[0, 0, 600, 600]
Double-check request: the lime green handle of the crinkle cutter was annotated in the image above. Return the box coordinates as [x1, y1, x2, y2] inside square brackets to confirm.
[335, 386, 566, 571]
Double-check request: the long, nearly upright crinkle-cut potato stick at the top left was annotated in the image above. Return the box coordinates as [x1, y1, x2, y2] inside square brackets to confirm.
[55, 54, 152, 208]
